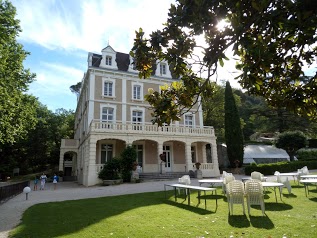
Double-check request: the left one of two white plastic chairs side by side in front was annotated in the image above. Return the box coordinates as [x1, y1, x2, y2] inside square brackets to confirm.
[226, 180, 245, 215]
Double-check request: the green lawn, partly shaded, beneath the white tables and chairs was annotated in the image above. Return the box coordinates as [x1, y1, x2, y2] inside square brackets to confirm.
[10, 183, 317, 238]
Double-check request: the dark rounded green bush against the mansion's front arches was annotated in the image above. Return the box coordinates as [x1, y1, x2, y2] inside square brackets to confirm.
[98, 158, 122, 185]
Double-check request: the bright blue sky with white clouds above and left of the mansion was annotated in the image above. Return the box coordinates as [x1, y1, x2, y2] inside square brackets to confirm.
[11, 0, 244, 112]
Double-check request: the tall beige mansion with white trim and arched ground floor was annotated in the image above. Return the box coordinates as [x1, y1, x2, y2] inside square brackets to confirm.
[59, 46, 220, 186]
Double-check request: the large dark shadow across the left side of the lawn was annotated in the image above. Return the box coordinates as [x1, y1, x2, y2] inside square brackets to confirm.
[10, 192, 173, 238]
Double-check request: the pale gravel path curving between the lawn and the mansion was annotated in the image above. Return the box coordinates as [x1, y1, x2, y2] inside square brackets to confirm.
[0, 175, 302, 238]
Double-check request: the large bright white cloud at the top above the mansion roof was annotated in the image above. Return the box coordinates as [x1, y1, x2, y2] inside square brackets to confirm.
[13, 0, 173, 52]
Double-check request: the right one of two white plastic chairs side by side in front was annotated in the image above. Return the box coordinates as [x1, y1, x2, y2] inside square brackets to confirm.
[245, 179, 265, 216]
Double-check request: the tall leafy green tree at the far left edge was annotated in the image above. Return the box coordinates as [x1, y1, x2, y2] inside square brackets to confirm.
[0, 0, 36, 143]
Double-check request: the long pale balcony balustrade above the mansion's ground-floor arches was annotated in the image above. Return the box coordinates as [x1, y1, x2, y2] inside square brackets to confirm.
[90, 120, 215, 137]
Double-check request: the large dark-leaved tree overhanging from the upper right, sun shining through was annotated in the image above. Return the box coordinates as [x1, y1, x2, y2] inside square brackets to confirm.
[130, 0, 317, 124]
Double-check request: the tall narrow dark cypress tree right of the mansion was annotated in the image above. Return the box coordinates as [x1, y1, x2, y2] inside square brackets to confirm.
[225, 81, 244, 167]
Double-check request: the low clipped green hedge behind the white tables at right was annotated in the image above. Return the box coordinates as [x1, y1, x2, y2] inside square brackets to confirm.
[245, 160, 317, 175]
